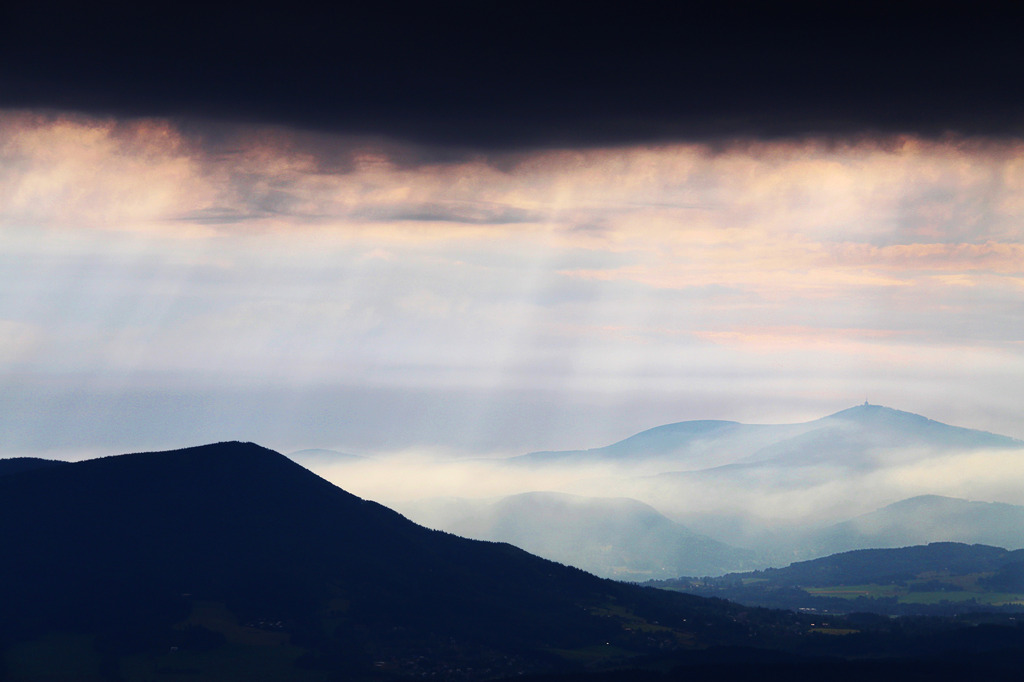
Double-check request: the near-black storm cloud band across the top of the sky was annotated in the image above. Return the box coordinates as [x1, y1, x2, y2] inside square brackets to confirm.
[6, 2, 1024, 148]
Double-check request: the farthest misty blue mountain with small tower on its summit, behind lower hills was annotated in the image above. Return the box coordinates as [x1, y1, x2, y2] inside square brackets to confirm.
[514, 404, 1024, 548]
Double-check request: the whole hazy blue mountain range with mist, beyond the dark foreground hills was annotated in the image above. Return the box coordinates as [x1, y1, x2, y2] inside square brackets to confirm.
[389, 403, 1024, 580]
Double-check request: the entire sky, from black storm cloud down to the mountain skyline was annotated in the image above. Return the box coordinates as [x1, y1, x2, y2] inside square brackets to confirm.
[0, 3, 1024, 458]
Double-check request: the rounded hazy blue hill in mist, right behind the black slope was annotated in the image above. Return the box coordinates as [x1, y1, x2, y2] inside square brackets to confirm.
[402, 493, 763, 581]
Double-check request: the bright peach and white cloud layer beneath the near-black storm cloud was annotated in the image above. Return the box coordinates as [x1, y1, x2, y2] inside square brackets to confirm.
[0, 111, 1024, 452]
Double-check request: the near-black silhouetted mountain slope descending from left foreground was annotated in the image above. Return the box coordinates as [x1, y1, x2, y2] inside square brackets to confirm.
[0, 442, 774, 680]
